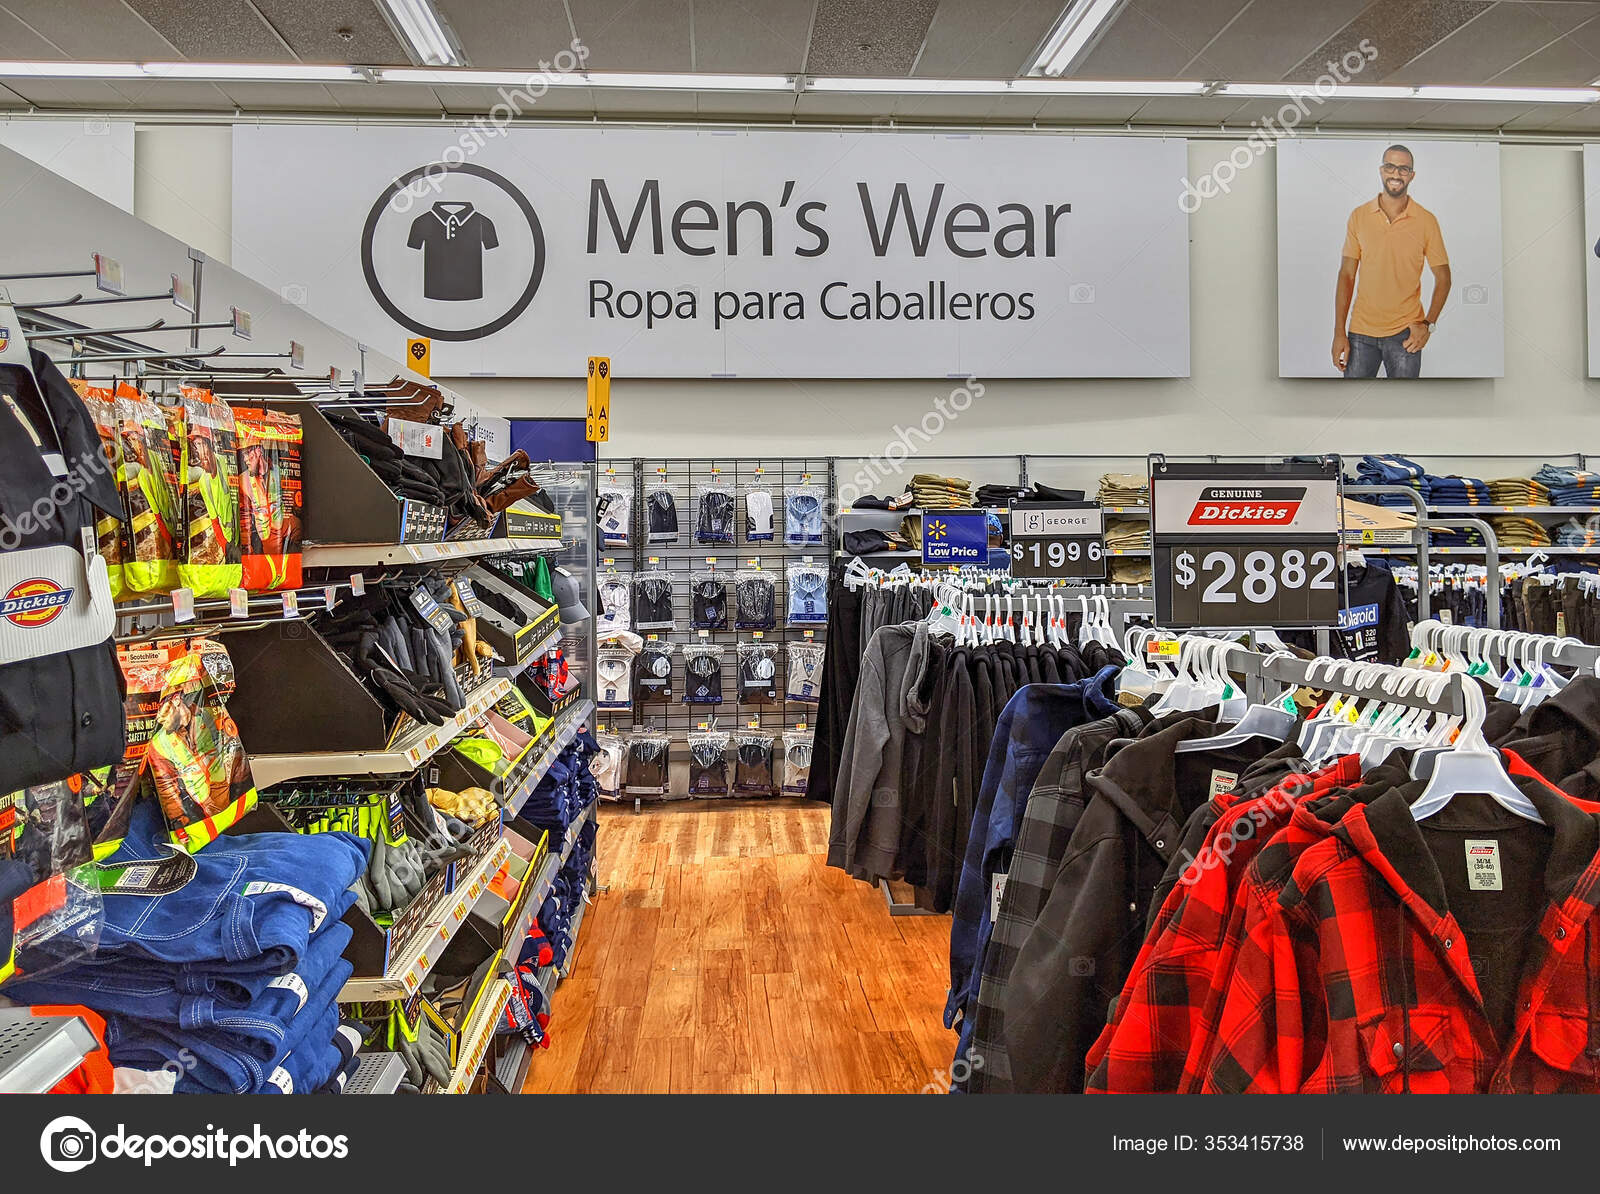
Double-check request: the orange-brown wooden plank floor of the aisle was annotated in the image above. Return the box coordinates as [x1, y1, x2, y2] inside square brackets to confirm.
[523, 800, 955, 1093]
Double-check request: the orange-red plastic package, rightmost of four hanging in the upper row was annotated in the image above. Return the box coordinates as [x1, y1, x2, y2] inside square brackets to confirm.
[234, 408, 304, 592]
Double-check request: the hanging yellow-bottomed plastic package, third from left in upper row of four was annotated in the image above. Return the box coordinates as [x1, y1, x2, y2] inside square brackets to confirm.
[178, 387, 243, 597]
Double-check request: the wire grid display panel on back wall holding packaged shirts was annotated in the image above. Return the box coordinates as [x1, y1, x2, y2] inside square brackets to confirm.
[595, 456, 837, 799]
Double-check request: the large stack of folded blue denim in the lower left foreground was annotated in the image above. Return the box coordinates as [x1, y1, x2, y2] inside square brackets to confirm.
[5, 802, 370, 1095]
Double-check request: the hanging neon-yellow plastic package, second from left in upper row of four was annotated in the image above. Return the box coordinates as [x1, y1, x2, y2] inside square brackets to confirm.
[117, 384, 179, 592]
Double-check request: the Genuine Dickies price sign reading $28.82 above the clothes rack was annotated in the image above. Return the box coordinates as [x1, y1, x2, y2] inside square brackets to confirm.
[1150, 459, 1344, 629]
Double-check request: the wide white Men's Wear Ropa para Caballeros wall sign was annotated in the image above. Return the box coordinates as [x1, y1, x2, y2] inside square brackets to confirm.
[234, 125, 1189, 378]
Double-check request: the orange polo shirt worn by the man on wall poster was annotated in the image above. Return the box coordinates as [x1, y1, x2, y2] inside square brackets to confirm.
[1344, 198, 1450, 336]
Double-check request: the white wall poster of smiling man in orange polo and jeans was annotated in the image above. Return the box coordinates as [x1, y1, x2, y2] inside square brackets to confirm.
[1277, 136, 1506, 379]
